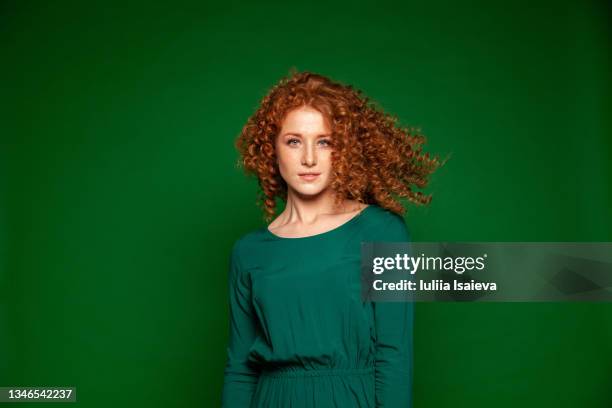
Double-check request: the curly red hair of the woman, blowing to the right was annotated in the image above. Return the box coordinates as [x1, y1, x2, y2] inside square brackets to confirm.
[235, 69, 441, 222]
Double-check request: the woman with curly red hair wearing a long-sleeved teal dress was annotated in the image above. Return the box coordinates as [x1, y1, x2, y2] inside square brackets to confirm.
[223, 72, 439, 408]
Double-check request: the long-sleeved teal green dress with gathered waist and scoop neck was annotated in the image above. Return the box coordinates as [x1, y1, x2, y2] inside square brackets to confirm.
[222, 205, 414, 408]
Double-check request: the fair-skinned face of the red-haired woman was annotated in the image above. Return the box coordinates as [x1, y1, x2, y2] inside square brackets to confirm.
[275, 106, 332, 196]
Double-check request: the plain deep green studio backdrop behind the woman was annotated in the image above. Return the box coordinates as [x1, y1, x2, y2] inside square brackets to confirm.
[0, 0, 612, 408]
